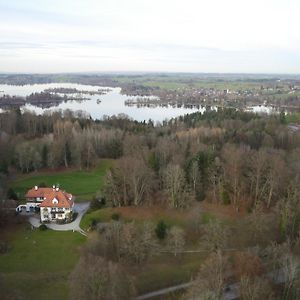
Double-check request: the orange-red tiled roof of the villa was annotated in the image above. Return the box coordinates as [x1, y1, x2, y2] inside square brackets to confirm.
[26, 188, 73, 207]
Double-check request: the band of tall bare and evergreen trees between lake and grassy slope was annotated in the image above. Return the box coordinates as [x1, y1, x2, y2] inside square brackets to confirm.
[0, 109, 300, 217]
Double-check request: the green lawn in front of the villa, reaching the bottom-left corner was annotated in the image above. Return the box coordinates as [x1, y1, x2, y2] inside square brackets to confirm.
[0, 225, 86, 300]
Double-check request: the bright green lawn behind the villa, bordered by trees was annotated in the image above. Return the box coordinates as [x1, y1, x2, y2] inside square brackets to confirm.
[11, 160, 112, 201]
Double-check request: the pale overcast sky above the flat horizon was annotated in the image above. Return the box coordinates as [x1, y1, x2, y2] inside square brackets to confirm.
[0, 0, 300, 74]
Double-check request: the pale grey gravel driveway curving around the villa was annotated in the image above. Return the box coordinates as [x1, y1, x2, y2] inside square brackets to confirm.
[29, 202, 90, 235]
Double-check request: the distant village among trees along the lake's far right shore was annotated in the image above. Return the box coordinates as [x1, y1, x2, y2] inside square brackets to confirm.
[122, 82, 300, 109]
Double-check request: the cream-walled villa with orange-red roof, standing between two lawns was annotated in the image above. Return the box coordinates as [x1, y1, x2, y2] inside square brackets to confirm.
[26, 186, 74, 222]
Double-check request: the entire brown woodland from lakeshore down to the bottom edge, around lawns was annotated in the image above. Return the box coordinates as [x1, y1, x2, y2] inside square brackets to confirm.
[0, 108, 300, 299]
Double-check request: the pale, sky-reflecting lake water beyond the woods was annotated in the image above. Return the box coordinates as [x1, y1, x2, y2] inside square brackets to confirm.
[0, 83, 205, 122]
